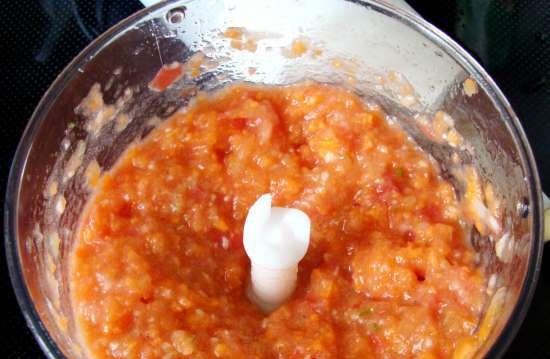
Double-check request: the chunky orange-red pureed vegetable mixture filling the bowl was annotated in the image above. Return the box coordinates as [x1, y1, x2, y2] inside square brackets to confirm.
[70, 83, 485, 359]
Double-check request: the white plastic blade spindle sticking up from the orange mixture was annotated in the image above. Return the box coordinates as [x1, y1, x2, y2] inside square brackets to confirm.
[243, 194, 311, 312]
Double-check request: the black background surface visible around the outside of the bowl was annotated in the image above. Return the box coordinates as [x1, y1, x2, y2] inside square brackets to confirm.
[0, 0, 550, 358]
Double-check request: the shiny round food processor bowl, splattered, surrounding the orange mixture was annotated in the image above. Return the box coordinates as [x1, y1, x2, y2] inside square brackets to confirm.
[5, 0, 543, 358]
